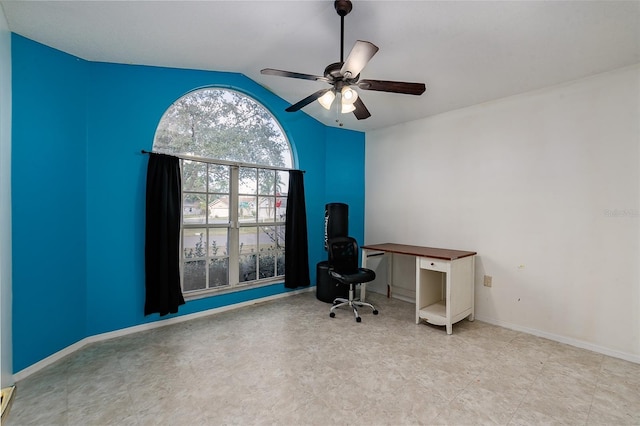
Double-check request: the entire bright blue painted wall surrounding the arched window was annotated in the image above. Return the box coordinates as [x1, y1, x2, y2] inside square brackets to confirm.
[12, 34, 364, 372]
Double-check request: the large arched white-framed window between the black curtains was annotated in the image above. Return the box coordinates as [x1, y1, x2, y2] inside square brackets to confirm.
[153, 88, 292, 297]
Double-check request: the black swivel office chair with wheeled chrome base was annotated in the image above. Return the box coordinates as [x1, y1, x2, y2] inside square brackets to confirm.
[327, 237, 378, 322]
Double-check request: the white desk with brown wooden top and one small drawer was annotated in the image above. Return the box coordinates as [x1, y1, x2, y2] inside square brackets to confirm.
[360, 243, 477, 334]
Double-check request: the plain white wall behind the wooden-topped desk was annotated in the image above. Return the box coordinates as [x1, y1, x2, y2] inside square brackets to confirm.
[365, 66, 640, 362]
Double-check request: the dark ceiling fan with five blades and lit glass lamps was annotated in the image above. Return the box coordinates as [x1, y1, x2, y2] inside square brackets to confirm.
[260, 0, 426, 120]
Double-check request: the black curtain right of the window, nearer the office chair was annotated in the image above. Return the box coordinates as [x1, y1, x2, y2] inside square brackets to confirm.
[284, 170, 311, 288]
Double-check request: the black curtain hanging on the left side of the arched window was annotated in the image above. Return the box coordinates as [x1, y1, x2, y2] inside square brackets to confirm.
[144, 153, 184, 315]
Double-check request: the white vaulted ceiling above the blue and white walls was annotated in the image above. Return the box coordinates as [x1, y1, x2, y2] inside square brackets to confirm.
[0, 0, 640, 131]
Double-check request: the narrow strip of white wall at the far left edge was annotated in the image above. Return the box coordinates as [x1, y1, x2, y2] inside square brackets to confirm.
[0, 5, 13, 388]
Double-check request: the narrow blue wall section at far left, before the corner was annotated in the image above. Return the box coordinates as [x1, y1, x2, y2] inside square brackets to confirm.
[11, 34, 88, 371]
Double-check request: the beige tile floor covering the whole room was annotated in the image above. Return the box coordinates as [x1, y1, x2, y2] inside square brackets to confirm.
[3, 292, 640, 426]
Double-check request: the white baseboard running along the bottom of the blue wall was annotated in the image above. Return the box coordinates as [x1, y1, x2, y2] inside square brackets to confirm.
[13, 286, 315, 382]
